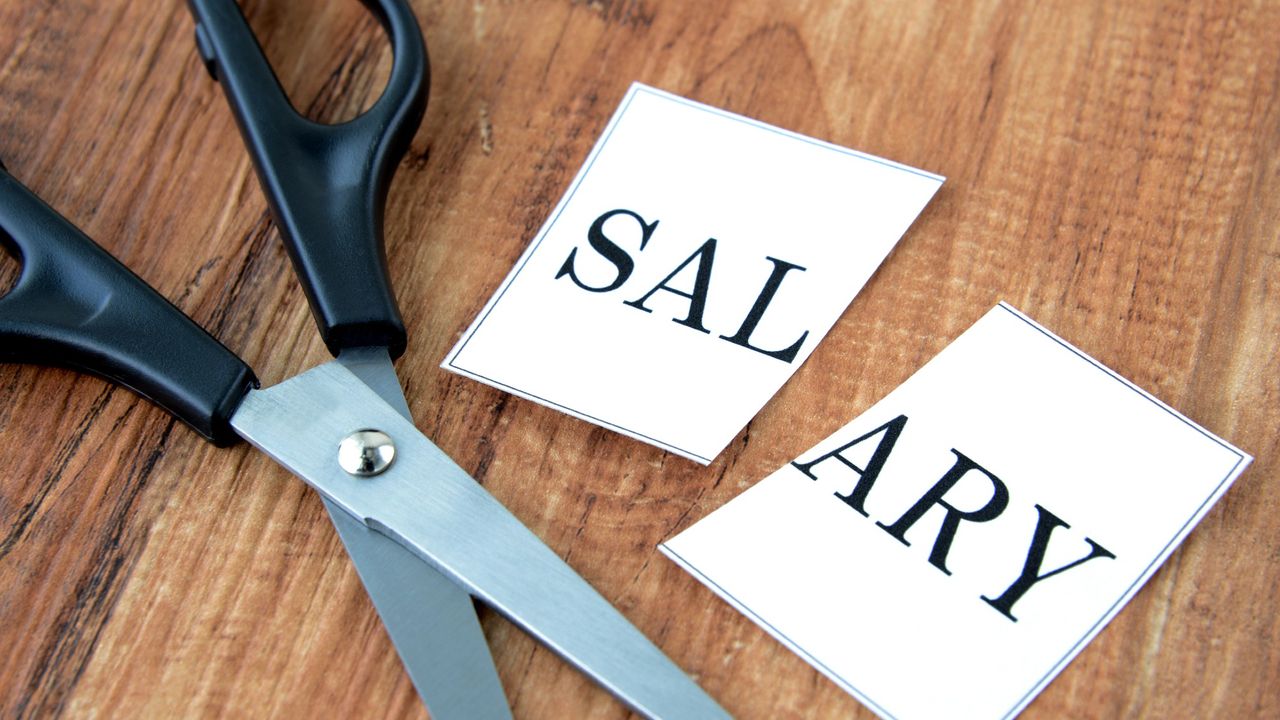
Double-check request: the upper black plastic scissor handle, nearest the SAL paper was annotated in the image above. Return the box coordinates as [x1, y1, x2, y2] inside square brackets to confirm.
[187, 0, 429, 357]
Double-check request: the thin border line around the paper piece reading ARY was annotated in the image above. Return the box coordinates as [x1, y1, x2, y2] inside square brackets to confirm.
[660, 301, 1248, 720]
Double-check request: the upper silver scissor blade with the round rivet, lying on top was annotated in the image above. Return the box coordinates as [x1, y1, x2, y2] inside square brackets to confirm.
[232, 363, 727, 717]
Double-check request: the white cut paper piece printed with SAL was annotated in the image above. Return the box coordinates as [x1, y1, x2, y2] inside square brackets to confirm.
[442, 85, 942, 464]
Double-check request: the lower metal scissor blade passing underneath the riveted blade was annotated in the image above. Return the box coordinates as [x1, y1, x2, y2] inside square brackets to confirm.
[324, 347, 511, 720]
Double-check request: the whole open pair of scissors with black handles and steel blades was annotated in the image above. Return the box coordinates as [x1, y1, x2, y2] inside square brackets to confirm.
[0, 0, 727, 720]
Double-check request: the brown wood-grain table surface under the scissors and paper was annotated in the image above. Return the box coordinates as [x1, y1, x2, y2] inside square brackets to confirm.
[0, 0, 1280, 719]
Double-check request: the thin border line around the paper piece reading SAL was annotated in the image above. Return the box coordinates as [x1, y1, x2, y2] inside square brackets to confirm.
[444, 83, 945, 465]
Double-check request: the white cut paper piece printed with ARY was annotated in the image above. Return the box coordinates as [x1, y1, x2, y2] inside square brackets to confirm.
[662, 304, 1251, 720]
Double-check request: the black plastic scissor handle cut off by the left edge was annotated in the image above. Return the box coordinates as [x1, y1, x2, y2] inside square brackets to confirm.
[0, 165, 257, 445]
